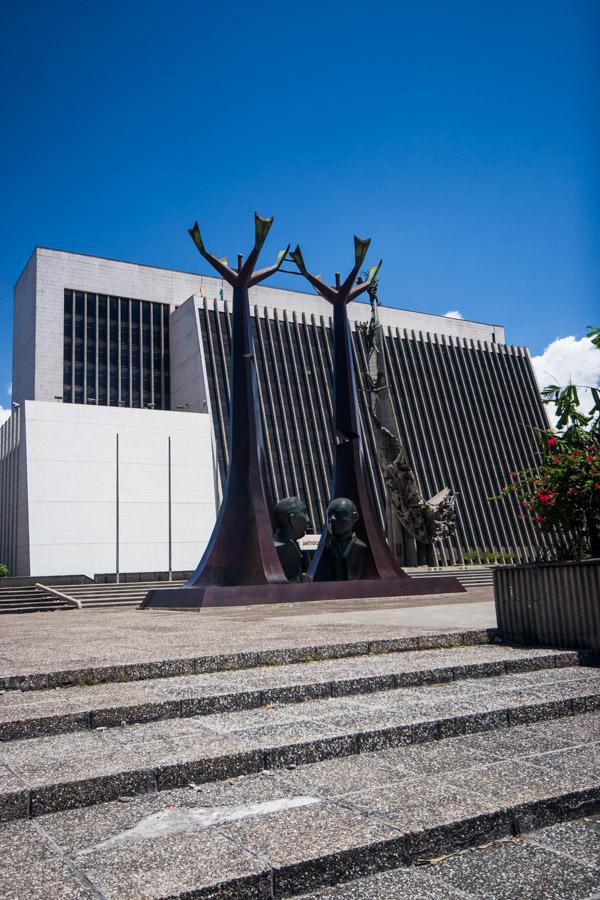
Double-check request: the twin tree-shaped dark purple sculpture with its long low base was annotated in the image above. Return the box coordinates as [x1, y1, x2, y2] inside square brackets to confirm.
[142, 221, 464, 609]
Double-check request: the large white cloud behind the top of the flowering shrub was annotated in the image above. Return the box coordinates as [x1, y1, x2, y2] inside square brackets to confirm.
[531, 335, 600, 428]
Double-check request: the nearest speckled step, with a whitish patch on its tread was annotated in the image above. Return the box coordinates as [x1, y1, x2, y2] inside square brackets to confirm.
[0, 712, 600, 900]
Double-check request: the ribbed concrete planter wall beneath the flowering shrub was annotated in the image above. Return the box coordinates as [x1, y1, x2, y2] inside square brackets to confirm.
[494, 559, 600, 652]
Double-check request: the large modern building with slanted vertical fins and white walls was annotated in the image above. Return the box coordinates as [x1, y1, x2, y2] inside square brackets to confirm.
[0, 247, 548, 576]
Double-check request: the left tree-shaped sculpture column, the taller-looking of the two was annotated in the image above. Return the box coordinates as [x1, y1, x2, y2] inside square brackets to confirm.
[186, 214, 289, 587]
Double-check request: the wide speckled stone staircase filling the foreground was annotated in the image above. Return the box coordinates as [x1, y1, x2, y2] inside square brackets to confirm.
[0, 631, 600, 900]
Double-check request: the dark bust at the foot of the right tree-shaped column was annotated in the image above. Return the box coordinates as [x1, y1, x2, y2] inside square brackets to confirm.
[323, 497, 367, 581]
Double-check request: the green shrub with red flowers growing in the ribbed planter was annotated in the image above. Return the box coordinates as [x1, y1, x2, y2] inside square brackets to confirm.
[494, 328, 600, 557]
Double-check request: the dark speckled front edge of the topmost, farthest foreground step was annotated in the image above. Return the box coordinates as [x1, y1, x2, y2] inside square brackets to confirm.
[0, 620, 496, 691]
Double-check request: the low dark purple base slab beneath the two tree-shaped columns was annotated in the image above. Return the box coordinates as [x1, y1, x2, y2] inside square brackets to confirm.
[141, 575, 465, 609]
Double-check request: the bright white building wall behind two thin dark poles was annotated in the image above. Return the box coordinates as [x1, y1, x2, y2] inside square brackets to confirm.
[22, 402, 215, 575]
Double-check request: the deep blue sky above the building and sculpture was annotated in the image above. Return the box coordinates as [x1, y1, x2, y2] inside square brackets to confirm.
[0, 0, 600, 414]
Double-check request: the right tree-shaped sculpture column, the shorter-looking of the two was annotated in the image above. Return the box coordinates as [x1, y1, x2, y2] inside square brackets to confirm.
[291, 236, 405, 581]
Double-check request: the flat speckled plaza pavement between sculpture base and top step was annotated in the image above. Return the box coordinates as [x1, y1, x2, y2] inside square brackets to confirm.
[0, 587, 496, 685]
